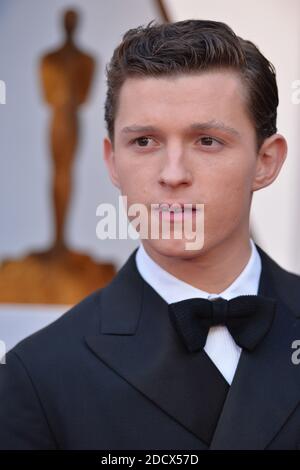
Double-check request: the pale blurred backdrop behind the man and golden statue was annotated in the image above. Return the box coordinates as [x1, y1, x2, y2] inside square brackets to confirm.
[0, 0, 300, 355]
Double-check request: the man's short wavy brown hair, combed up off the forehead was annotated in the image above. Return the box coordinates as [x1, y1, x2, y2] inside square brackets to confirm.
[105, 20, 278, 148]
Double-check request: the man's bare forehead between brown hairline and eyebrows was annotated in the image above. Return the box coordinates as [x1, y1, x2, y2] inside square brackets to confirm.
[116, 71, 245, 132]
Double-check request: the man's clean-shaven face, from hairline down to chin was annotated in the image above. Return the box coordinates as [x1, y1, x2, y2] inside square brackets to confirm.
[104, 71, 257, 258]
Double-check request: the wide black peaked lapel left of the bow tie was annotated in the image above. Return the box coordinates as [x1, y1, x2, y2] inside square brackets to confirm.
[86, 250, 229, 448]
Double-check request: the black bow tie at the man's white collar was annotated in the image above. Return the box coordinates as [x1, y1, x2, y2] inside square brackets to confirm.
[169, 295, 276, 352]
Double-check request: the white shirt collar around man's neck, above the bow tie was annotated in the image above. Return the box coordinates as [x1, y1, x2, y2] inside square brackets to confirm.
[136, 239, 261, 303]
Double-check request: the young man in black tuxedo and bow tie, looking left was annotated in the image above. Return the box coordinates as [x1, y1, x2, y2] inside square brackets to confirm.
[0, 20, 300, 450]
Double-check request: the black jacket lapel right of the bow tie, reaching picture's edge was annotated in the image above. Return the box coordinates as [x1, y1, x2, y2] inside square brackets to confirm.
[210, 246, 300, 450]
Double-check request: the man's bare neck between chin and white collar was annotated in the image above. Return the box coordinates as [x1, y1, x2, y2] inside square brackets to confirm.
[144, 232, 251, 294]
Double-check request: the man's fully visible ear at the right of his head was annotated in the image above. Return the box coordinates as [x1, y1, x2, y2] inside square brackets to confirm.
[252, 134, 287, 191]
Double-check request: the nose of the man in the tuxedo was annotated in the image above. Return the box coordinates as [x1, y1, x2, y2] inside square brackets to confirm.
[159, 144, 192, 188]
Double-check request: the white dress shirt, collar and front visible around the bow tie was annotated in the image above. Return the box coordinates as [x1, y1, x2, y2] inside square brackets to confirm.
[136, 239, 261, 384]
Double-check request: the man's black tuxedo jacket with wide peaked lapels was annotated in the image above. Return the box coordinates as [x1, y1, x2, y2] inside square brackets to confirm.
[0, 247, 300, 450]
